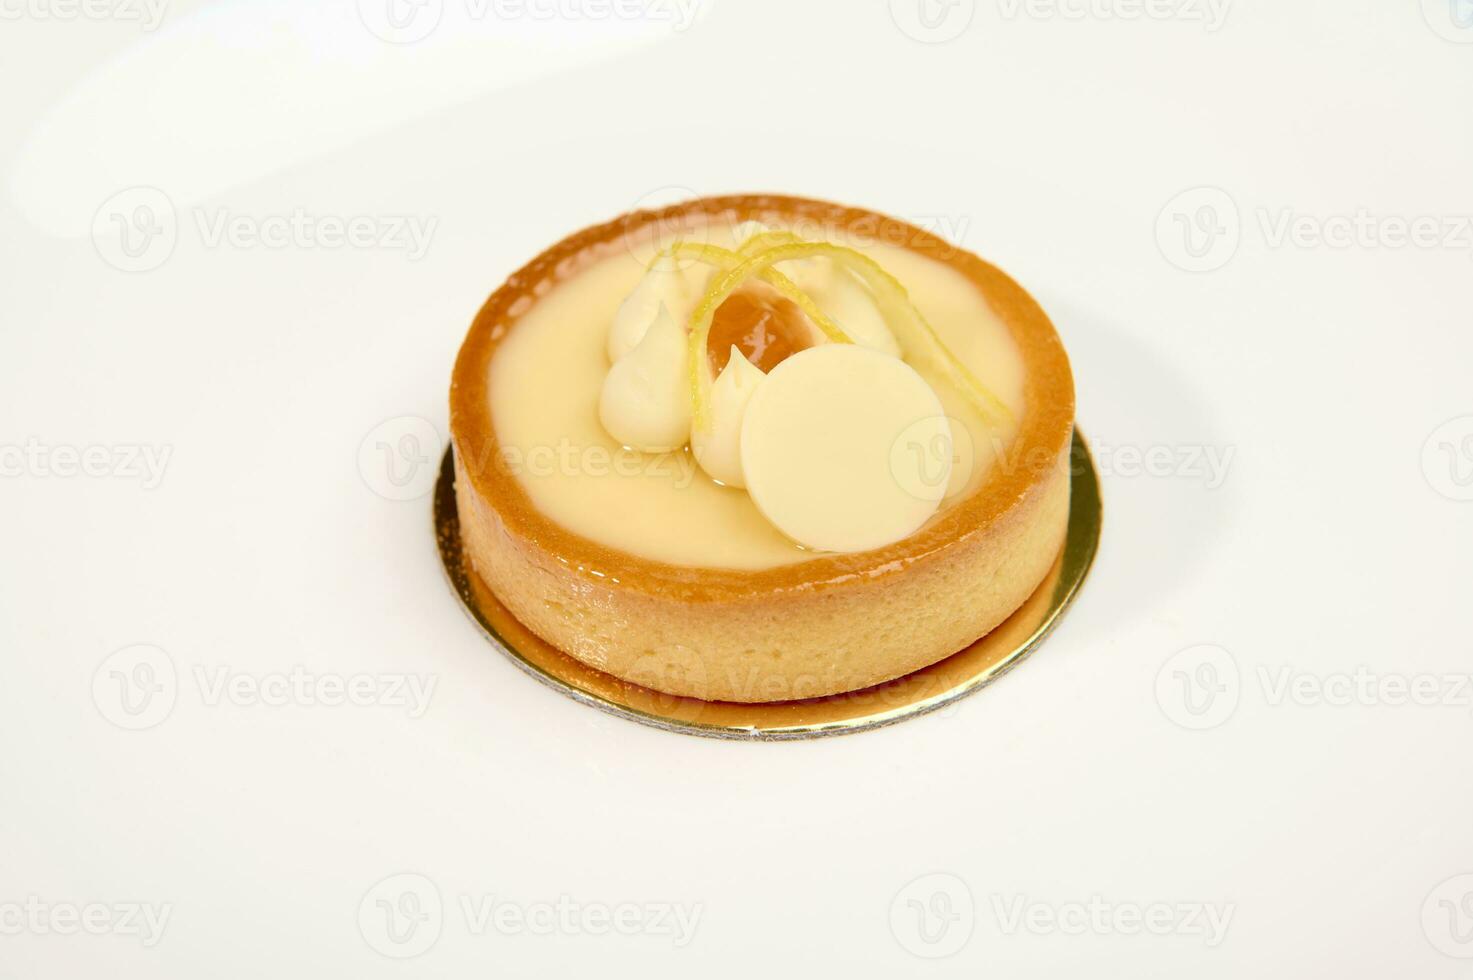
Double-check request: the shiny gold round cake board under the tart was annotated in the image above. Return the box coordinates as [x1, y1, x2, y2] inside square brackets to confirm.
[435, 429, 1102, 741]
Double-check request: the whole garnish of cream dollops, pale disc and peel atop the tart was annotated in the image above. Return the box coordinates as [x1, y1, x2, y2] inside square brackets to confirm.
[598, 221, 1008, 553]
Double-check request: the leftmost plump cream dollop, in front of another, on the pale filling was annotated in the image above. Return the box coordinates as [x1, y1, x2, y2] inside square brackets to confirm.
[598, 304, 691, 452]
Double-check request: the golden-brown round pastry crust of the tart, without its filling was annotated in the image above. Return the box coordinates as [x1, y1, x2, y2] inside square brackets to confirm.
[451, 195, 1074, 701]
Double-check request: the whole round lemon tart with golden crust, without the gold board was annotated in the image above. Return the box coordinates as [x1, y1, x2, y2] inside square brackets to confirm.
[451, 196, 1074, 703]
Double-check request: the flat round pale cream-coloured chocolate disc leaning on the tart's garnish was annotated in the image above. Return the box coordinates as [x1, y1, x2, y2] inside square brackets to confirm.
[741, 343, 952, 553]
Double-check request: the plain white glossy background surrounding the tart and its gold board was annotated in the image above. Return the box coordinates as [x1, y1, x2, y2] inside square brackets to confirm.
[0, 0, 1473, 979]
